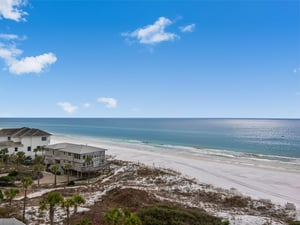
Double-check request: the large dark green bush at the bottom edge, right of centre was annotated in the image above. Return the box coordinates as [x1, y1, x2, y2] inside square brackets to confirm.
[137, 206, 222, 225]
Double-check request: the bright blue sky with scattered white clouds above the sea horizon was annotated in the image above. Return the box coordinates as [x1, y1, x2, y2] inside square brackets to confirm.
[0, 0, 300, 118]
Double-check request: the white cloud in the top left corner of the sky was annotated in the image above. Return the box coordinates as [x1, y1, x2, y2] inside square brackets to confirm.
[0, 0, 27, 22]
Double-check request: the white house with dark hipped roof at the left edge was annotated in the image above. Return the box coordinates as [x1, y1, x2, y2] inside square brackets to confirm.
[0, 127, 51, 158]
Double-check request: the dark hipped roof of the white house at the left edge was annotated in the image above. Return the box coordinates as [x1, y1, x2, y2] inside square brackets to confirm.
[0, 127, 51, 137]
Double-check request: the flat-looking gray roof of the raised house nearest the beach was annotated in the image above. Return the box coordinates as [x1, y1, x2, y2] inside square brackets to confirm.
[45, 143, 106, 154]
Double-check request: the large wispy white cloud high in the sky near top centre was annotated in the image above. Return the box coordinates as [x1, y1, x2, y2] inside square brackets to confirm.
[122, 17, 179, 45]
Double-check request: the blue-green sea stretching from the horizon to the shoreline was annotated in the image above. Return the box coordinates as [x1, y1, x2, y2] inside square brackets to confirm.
[0, 118, 300, 158]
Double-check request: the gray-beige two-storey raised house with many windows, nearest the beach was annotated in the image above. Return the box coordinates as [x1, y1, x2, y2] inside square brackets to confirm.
[44, 143, 106, 175]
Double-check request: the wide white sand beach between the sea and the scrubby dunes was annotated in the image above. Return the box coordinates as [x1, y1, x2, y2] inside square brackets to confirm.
[51, 135, 300, 210]
